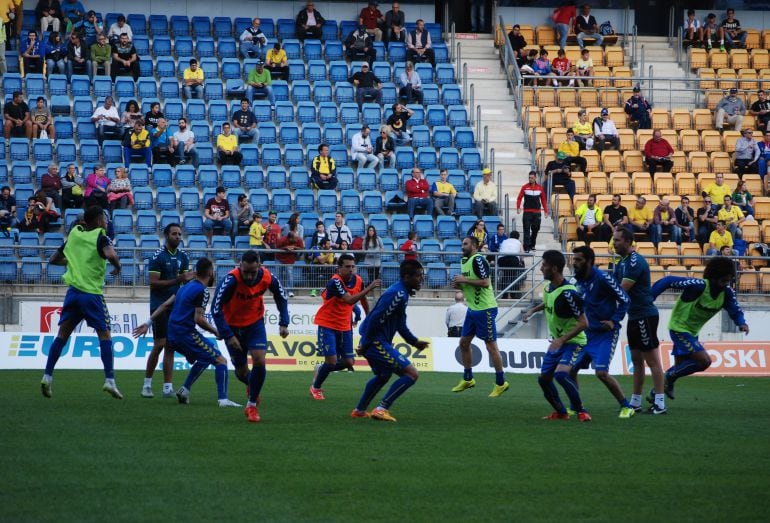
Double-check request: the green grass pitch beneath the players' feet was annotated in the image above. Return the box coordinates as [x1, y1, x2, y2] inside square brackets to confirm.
[0, 370, 770, 522]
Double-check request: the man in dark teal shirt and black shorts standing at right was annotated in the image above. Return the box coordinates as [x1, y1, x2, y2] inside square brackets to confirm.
[613, 227, 666, 414]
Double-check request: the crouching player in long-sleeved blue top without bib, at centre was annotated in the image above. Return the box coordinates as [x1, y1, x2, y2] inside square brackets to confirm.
[350, 260, 428, 421]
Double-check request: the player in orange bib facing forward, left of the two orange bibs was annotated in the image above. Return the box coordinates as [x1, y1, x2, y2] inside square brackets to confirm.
[211, 250, 289, 423]
